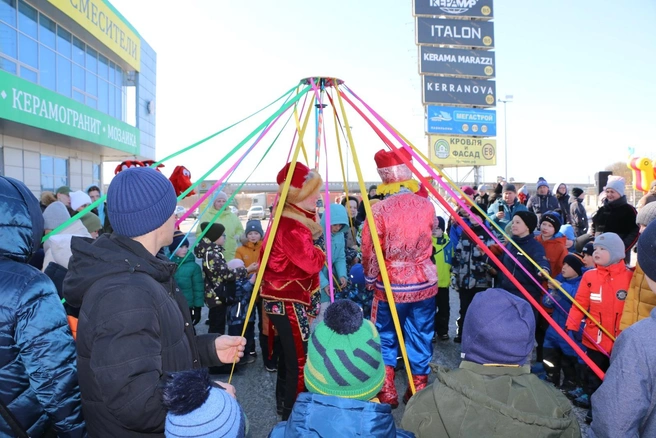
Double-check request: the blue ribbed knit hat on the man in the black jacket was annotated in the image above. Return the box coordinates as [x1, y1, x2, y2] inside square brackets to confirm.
[107, 167, 178, 237]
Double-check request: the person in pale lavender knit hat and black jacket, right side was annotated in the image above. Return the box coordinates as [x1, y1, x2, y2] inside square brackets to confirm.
[590, 177, 640, 263]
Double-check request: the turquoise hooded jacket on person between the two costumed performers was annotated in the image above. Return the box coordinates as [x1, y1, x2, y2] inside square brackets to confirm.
[319, 204, 349, 302]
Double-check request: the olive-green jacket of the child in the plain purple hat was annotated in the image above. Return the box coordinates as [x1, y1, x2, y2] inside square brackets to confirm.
[401, 361, 581, 438]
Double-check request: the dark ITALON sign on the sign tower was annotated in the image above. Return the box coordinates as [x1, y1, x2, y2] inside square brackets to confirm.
[415, 17, 494, 49]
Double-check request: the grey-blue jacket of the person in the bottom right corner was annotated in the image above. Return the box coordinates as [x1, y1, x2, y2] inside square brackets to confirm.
[588, 310, 656, 438]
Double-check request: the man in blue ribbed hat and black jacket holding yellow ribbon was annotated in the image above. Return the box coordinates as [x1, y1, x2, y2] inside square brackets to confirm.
[64, 168, 246, 437]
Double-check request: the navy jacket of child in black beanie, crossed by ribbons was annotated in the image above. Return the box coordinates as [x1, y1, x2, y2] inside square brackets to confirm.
[500, 234, 551, 302]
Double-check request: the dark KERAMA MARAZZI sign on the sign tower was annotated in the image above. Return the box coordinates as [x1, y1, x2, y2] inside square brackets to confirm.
[419, 46, 494, 78]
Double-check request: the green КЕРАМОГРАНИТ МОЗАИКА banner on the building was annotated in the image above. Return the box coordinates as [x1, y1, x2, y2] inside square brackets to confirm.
[0, 71, 140, 155]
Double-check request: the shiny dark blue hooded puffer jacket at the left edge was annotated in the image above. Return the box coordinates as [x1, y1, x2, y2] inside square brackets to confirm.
[0, 177, 86, 437]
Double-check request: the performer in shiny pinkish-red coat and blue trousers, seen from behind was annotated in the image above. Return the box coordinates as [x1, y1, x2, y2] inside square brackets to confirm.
[362, 149, 437, 408]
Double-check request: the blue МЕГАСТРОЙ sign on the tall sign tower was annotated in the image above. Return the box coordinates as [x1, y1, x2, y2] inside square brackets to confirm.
[426, 105, 497, 137]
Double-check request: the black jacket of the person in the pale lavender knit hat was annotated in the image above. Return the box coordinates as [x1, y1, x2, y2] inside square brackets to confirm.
[591, 196, 640, 253]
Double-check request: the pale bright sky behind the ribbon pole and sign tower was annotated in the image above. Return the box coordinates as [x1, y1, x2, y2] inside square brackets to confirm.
[105, 0, 656, 183]
